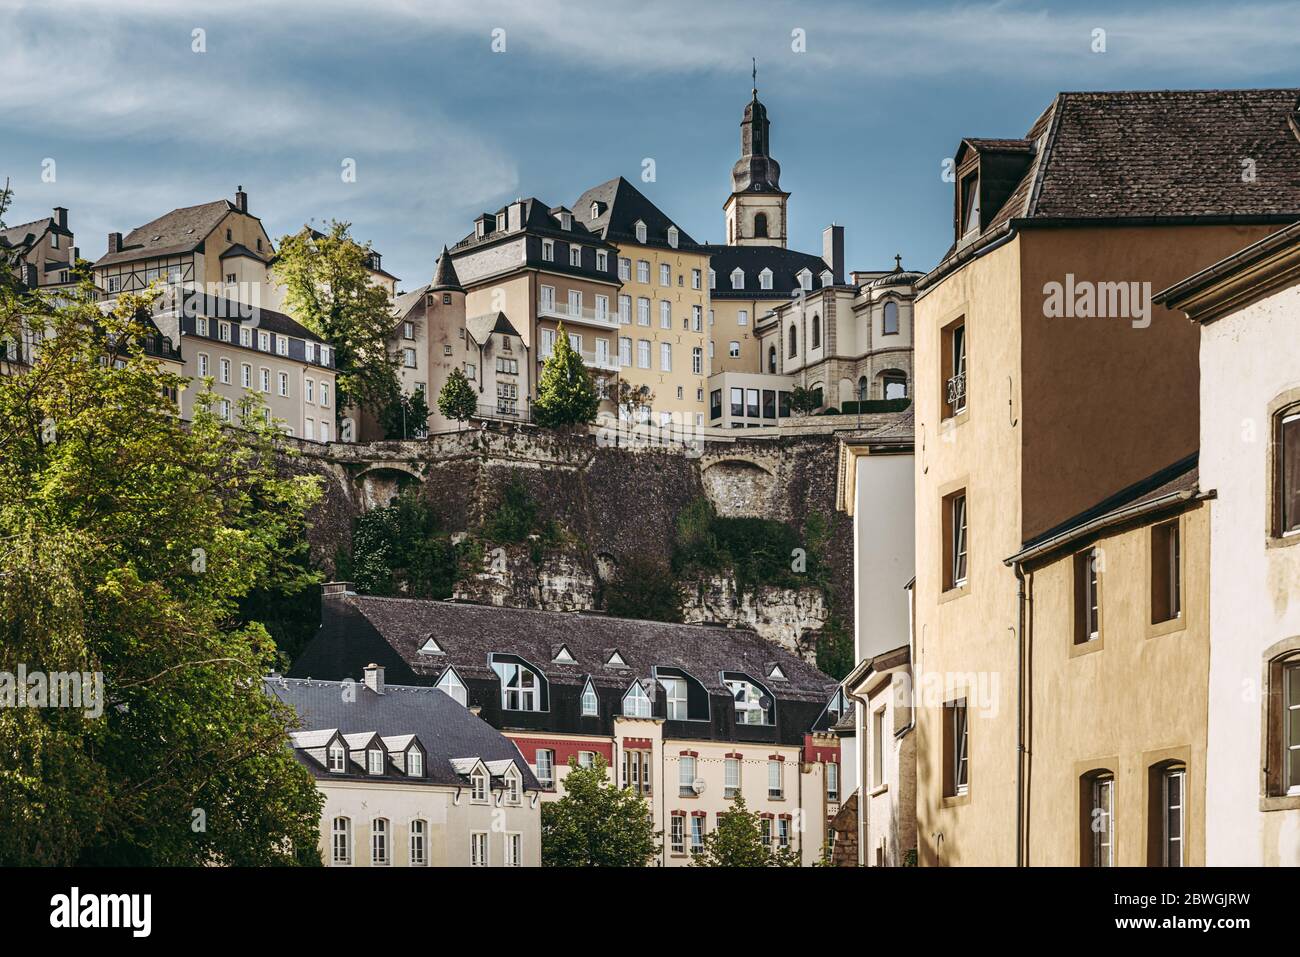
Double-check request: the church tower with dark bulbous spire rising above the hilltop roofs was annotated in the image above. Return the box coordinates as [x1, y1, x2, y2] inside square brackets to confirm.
[723, 65, 790, 248]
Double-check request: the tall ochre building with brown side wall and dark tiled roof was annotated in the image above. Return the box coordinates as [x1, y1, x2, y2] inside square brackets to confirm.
[913, 90, 1300, 865]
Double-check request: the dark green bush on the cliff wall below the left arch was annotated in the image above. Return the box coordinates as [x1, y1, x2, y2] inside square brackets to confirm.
[343, 488, 459, 599]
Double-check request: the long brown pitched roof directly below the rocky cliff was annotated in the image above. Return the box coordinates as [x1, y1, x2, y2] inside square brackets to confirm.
[291, 594, 836, 703]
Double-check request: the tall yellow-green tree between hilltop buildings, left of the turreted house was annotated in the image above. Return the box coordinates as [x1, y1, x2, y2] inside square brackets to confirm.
[274, 221, 399, 415]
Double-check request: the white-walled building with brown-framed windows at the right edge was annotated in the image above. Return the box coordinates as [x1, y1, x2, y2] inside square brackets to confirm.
[1157, 226, 1300, 866]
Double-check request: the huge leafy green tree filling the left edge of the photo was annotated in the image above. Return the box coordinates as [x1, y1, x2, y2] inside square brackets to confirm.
[0, 285, 321, 866]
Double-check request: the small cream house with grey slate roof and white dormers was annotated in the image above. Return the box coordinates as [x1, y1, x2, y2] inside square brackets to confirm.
[267, 666, 542, 867]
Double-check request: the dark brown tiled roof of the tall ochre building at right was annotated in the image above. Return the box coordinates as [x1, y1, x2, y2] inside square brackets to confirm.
[924, 88, 1300, 285]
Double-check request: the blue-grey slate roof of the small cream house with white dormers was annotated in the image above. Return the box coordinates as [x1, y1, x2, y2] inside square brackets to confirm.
[264, 675, 541, 791]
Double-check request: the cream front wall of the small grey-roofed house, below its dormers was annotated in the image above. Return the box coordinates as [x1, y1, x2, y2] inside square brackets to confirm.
[317, 778, 542, 867]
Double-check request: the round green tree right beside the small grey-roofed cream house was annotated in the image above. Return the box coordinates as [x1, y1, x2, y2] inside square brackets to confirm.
[542, 755, 663, 867]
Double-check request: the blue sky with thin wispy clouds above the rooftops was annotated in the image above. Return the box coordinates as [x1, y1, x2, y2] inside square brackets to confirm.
[0, 0, 1300, 289]
